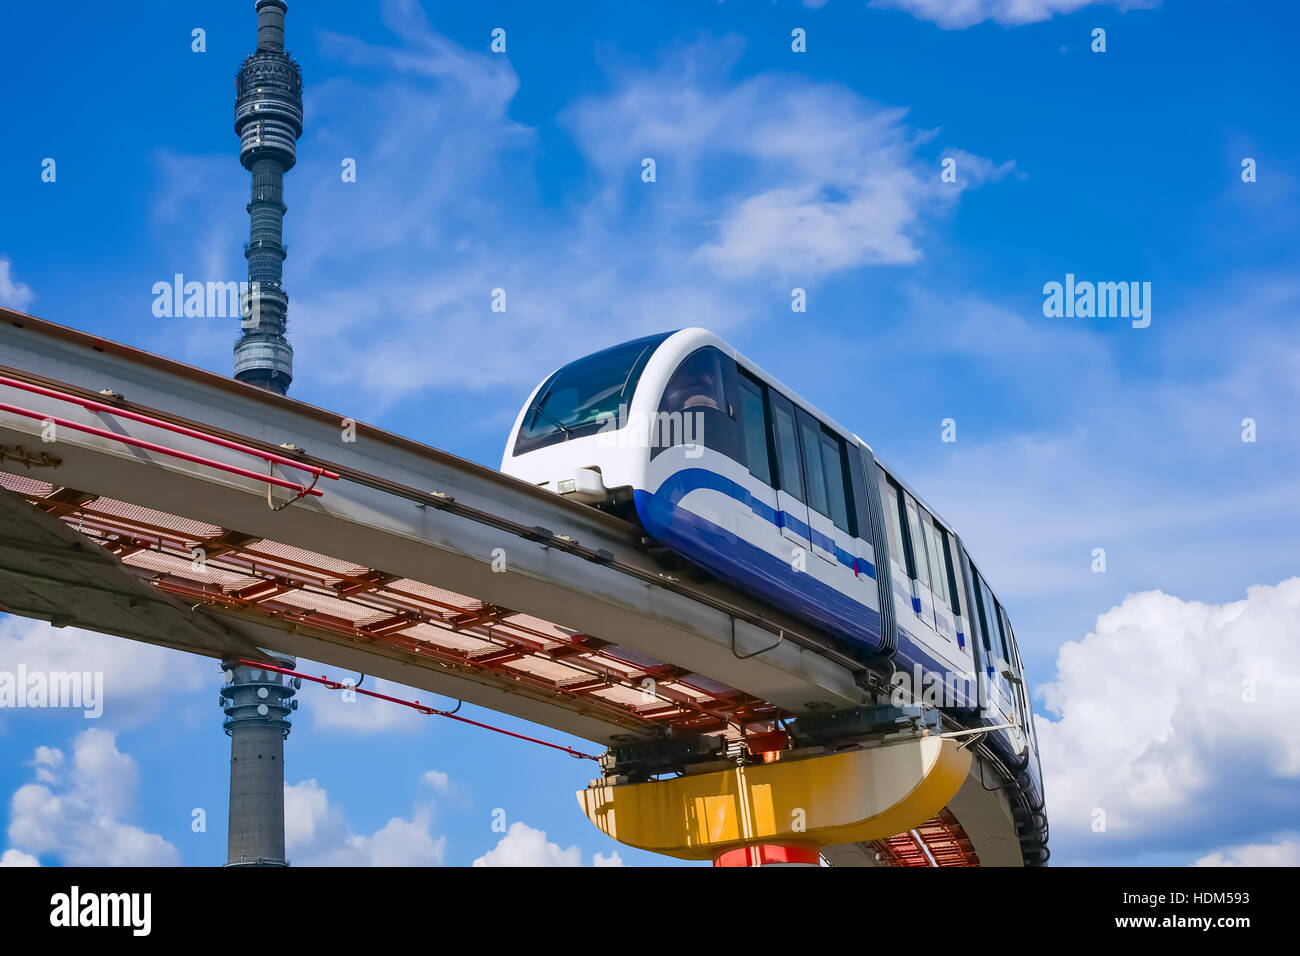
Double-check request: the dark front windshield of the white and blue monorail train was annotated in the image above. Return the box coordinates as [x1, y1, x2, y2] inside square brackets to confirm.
[515, 332, 672, 455]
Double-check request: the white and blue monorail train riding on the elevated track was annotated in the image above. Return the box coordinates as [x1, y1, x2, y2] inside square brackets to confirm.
[502, 329, 1045, 858]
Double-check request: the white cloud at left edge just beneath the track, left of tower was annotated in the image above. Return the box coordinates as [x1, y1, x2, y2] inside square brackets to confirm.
[0, 615, 205, 726]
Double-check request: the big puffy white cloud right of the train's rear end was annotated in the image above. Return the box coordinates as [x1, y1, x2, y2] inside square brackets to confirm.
[1037, 578, 1300, 858]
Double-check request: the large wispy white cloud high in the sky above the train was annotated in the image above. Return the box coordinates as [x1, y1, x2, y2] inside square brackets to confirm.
[564, 59, 993, 281]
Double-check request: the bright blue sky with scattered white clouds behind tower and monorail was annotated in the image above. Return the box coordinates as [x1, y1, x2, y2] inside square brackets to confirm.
[0, 0, 1300, 864]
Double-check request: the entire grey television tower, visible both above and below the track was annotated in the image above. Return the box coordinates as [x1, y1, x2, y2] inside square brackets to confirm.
[221, 0, 303, 866]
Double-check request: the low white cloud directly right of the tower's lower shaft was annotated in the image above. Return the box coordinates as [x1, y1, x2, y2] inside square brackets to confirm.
[285, 779, 447, 866]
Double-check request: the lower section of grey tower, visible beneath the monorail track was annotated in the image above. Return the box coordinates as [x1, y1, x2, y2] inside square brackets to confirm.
[221, 654, 302, 866]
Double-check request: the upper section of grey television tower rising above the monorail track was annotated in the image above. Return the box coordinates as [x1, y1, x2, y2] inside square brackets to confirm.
[235, 0, 303, 394]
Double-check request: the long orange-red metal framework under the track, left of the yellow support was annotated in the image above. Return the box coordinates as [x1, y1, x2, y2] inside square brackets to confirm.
[0, 472, 787, 736]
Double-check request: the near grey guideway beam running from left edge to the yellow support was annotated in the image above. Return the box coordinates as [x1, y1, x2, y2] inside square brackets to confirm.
[0, 311, 867, 744]
